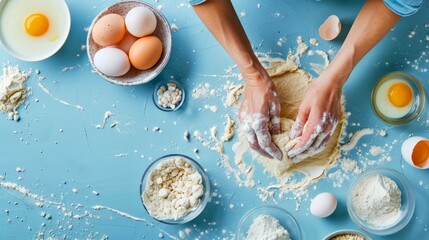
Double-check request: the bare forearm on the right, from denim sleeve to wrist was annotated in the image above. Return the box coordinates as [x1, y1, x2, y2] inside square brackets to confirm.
[327, 0, 400, 85]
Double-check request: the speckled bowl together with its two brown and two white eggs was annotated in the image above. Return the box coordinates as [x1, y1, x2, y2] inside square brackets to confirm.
[87, 1, 171, 86]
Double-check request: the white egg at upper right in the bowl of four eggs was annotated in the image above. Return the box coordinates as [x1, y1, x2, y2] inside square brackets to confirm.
[125, 6, 156, 37]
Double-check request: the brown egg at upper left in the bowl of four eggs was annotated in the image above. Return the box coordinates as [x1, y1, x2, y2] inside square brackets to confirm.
[92, 14, 127, 47]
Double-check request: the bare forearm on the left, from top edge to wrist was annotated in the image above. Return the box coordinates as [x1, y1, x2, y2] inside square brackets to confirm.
[194, 0, 261, 79]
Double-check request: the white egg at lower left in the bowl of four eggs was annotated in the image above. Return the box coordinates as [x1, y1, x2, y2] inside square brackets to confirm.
[94, 47, 131, 77]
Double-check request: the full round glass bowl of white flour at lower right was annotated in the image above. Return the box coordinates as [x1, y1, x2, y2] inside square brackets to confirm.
[347, 168, 415, 236]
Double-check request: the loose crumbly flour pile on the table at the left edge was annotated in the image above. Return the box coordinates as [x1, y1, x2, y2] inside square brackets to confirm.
[0, 66, 29, 121]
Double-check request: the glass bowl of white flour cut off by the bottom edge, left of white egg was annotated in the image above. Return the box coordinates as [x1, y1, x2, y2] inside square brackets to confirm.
[237, 206, 301, 240]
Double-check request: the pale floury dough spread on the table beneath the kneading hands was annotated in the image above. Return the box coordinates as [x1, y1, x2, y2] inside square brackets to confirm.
[224, 45, 346, 199]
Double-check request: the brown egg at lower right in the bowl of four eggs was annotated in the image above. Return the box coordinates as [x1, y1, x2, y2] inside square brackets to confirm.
[129, 36, 162, 70]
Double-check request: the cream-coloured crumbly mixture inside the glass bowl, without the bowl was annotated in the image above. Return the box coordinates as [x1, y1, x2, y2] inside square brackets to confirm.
[142, 157, 204, 220]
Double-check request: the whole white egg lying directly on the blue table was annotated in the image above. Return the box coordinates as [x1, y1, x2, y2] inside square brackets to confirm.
[310, 192, 337, 218]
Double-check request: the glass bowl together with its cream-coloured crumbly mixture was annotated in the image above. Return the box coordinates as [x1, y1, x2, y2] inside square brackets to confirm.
[140, 154, 210, 224]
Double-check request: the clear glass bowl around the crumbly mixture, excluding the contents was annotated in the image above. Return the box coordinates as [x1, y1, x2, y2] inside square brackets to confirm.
[140, 154, 210, 225]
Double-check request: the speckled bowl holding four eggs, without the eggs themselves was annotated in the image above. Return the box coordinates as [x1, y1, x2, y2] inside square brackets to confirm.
[86, 1, 171, 86]
